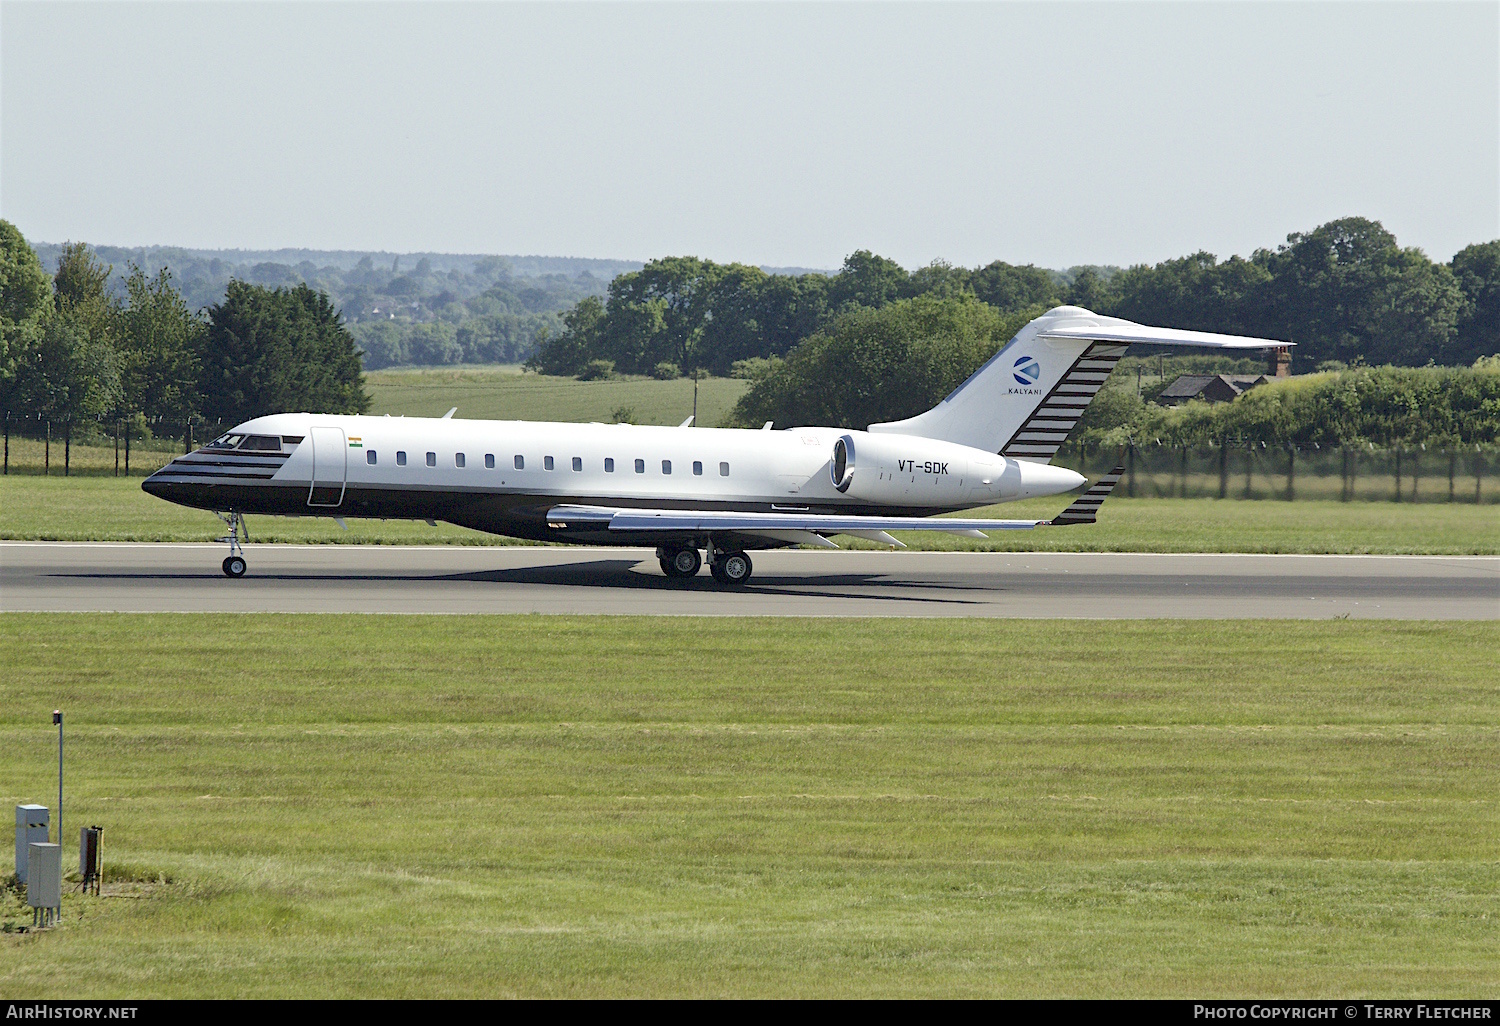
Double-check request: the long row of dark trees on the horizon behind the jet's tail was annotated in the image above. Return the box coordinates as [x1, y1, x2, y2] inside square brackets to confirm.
[528, 218, 1500, 377]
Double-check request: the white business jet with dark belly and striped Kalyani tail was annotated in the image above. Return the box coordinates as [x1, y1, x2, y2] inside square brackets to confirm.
[141, 306, 1289, 585]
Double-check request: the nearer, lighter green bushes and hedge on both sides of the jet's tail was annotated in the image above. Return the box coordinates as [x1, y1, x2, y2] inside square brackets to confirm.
[726, 288, 1500, 449]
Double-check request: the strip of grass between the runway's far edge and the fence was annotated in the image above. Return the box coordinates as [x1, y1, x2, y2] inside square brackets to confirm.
[0, 476, 1500, 555]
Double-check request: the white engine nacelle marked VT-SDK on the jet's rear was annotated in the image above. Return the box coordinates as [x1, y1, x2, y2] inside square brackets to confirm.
[828, 432, 1085, 506]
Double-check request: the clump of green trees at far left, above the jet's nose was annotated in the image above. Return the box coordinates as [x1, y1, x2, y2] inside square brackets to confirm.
[0, 221, 369, 428]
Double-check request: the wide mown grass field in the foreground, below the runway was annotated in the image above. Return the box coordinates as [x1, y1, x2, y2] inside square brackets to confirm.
[0, 614, 1500, 999]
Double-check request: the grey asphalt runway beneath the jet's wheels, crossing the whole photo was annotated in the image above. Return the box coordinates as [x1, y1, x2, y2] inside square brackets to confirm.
[0, 542, 1500, 620]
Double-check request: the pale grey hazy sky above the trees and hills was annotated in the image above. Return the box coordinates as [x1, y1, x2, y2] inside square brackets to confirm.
[0, 0, 1500, 267]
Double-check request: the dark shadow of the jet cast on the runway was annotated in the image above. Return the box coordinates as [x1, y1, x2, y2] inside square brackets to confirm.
[47, 560, 1008, 605]
